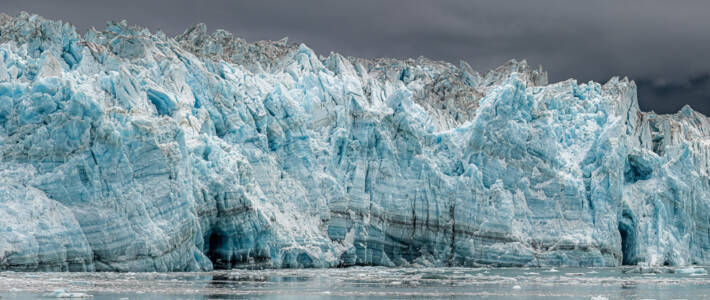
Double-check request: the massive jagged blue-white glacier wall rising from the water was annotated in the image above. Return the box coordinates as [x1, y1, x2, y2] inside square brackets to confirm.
[0, 13, 710, 271]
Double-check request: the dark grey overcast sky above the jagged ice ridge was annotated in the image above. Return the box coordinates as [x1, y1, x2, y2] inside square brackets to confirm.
[0, 0, 710, 115]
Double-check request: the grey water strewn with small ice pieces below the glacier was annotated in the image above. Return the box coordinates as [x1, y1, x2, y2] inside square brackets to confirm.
[0, 267, 710, 299]
